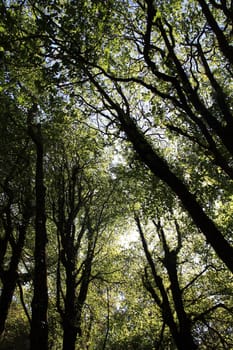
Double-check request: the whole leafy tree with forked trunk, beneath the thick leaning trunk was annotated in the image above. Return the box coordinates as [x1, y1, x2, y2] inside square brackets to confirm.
[108, 155, 232, 349]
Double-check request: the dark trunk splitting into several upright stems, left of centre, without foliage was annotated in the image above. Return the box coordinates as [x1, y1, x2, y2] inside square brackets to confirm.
[53, 165, 94, 350]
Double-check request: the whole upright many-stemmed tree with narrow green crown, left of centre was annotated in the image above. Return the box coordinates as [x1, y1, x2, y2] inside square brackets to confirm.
[47, 116, 118, 349]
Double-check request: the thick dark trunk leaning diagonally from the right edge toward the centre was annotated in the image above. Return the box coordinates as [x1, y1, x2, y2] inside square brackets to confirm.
[120, 107, 233, 272]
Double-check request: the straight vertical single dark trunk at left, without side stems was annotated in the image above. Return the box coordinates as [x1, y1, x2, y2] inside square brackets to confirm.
[29, 125, 48, 350]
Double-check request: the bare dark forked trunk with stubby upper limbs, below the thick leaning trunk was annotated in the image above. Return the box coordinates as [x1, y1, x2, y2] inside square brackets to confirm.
[135, 217, 197, 350]
